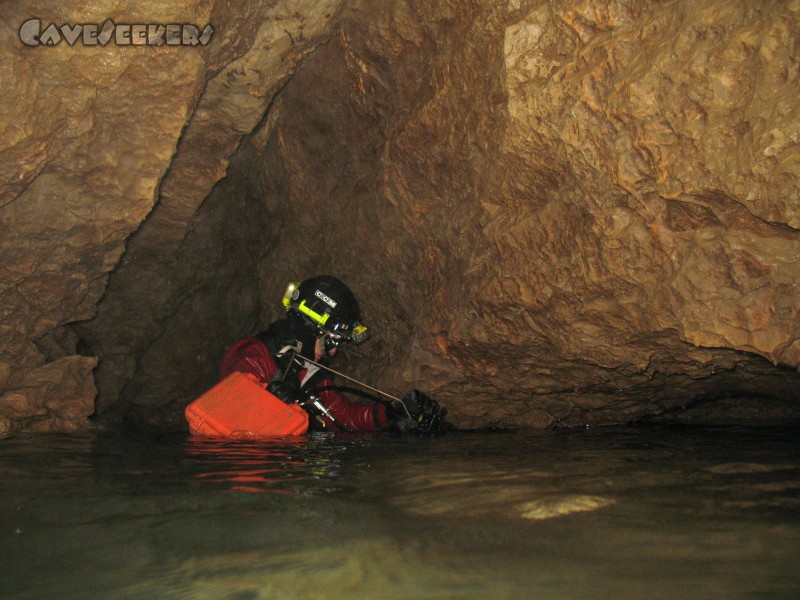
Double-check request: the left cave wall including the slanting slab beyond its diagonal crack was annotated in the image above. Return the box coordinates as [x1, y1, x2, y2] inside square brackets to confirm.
[0, 0, 339, 432]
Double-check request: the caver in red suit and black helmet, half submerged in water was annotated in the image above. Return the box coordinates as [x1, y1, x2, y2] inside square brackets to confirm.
[220, 275, 449, 434]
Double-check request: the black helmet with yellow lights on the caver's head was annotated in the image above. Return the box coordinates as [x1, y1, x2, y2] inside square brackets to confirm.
[283, 275, 368, 346]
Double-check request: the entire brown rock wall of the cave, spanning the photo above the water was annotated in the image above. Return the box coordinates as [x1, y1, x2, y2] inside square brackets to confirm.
[0, 0, 800, 430]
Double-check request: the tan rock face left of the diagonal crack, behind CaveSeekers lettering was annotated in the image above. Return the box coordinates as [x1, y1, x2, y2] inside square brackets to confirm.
[0, 1, 208, 428]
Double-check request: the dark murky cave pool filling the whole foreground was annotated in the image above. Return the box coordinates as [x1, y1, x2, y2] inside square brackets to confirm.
[0, 428, 800, 599]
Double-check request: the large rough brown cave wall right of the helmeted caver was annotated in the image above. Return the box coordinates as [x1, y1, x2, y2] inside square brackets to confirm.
[238, 2, 800, 427]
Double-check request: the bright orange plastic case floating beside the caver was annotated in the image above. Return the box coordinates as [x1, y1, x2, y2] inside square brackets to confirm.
[184, 372, 308, 439]
